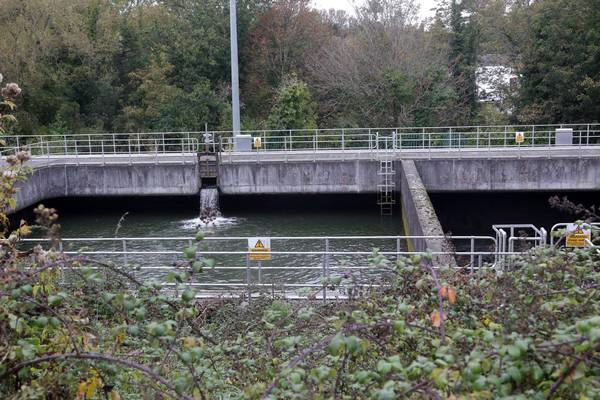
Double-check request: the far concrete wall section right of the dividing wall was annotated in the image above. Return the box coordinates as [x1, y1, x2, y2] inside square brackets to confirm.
[415, 157, 600, 192]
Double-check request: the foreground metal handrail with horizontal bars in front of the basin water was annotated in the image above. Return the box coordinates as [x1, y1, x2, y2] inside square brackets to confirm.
[21, 230, 596, 300]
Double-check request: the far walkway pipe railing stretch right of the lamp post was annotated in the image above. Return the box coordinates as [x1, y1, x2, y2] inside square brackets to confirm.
[220, 125, 600, 161]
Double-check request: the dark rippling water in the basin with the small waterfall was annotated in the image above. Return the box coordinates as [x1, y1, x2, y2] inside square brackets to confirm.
[20, 195, 405, 290]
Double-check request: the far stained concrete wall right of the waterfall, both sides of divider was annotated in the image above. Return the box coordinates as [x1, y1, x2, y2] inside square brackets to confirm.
[219, 157, 600, 194]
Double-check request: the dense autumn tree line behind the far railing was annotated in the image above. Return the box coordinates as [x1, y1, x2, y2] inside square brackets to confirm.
[0, 0, 600, 133]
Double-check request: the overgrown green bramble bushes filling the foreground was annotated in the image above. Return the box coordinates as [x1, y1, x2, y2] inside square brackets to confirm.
[0, 219, 600, 400]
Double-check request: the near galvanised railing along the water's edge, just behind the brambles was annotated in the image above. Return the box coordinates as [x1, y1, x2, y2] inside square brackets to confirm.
[18, 225, 591, 300]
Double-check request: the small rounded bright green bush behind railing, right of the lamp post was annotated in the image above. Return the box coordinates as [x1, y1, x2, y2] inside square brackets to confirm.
[267, 76, 317, 129]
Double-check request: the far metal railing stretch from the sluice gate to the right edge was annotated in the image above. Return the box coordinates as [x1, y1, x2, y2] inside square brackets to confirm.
[214, 124, 600, 162]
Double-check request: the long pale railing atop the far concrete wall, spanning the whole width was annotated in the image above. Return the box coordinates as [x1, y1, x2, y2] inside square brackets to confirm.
[1, 124, 600, 162]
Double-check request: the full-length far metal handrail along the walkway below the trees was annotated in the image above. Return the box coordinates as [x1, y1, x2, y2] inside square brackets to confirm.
[5, 123, 600, 157]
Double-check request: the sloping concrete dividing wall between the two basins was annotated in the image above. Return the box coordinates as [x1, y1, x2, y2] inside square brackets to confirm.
[398, 160, 456, 265]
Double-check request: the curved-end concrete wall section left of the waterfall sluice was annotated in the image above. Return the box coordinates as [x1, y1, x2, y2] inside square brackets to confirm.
[16, 164, 200, 210]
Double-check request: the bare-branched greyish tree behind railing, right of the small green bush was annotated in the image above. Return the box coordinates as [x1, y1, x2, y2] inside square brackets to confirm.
[309, 0, 457, 127]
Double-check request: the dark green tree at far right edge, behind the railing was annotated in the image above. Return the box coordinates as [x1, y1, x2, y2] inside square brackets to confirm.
[518, 0, 600, 123]
